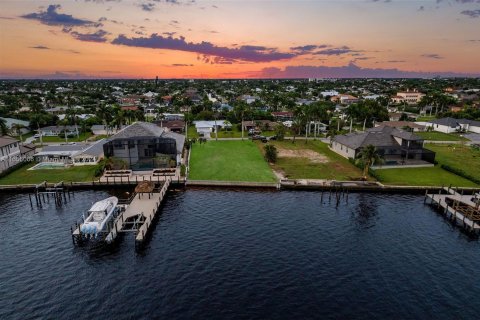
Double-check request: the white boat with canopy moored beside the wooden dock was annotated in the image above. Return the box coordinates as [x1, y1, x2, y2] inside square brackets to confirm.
[80, 197, 118, 236]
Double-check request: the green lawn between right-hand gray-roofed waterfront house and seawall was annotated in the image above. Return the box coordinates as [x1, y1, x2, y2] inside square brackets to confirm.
[375, 166, 477, 187]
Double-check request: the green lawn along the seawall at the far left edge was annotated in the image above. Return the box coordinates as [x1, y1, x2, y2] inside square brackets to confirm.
[0, 163, 96, 185]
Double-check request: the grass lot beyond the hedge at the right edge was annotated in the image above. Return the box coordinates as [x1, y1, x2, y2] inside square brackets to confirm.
[425, 144, 480, 179]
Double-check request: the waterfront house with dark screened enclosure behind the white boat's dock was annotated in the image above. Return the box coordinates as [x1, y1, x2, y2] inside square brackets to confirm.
[103, 122, 185, 170]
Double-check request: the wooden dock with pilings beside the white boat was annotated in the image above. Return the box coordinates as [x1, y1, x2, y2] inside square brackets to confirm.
[72, 178, 172, 244]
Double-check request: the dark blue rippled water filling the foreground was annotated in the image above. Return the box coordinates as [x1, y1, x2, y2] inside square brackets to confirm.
[0, 190, 480, 320]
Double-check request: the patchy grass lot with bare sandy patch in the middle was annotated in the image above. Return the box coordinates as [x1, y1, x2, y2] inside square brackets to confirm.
[266, 140, 362, 180]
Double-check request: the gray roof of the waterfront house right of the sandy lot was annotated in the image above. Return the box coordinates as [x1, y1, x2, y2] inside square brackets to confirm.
[333, 127, 423, 149]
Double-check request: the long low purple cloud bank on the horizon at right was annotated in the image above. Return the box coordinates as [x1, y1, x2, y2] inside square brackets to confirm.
[251, 62, 479, 78]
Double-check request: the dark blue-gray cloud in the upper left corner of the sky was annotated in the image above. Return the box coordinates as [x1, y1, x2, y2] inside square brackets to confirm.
[21, 4, 95, 27]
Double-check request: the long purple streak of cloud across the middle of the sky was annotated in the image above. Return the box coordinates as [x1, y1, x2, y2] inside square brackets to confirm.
[112, 33, 297, 62]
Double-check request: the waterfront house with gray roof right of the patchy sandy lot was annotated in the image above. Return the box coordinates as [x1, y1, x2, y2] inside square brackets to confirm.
[331, 126, 435, 166]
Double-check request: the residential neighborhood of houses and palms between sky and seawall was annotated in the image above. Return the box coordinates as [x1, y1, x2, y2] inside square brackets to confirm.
[0, 79, 480, 185]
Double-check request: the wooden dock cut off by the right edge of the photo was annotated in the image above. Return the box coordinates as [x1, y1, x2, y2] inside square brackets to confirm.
[424, 187, 480, 235]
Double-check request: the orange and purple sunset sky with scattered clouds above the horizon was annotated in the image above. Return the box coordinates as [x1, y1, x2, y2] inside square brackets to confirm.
[0, 0, 480, 79]
